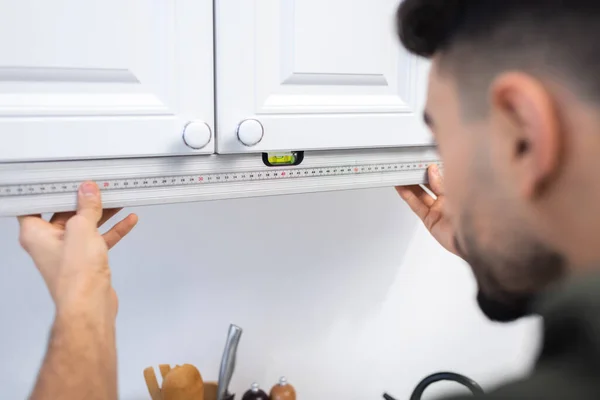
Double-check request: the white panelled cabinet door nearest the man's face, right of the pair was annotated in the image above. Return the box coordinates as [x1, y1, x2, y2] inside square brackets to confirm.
[215, 0, 432, 153]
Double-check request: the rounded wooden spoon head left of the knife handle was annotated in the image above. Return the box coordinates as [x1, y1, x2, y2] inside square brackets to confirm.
[161, 364, 204, 400]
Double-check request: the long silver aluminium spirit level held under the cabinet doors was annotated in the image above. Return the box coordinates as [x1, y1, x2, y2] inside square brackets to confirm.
[0, 148, 437, 216]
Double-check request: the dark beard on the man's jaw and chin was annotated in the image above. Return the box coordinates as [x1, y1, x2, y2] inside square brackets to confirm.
[462, 219, 566, 322]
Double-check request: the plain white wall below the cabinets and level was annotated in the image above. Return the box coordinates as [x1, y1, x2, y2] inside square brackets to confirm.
[0, 189, 538, 400]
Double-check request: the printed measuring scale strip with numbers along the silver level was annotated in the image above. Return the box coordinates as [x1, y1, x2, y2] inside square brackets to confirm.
[0, 162, 440, 198]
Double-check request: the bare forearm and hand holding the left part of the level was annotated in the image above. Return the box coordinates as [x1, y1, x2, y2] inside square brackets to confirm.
[19, 182, 137, 400]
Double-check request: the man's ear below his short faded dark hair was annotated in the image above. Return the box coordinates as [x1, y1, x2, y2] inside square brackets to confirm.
[490, 73, 562, 198]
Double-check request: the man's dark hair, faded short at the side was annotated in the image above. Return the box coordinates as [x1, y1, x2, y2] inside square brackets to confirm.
[396, 0, 600, 112]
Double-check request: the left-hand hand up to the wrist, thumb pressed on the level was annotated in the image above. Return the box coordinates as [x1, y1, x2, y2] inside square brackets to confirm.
[19, 182, 137, 315]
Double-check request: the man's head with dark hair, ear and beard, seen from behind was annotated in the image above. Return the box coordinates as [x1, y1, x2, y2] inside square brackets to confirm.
[397, 0, 600, 319]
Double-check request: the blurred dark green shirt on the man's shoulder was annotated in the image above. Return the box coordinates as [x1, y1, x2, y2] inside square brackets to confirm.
[446, 273, 600, 400]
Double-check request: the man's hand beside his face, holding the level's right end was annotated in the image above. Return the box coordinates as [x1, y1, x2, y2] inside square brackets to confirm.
[396, 165, 460, 256]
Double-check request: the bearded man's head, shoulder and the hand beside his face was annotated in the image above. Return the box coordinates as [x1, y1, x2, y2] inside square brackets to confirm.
[397, 0, 600, 399]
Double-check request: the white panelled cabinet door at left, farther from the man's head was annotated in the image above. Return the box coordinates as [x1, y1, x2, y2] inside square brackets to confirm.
[0, 0, 214, 161]
